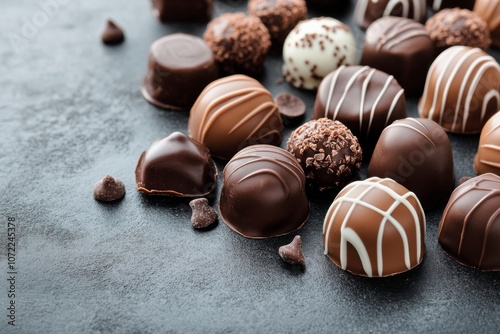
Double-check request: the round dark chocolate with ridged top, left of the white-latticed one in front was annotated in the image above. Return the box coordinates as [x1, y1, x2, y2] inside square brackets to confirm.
[219, 145, 309, 239]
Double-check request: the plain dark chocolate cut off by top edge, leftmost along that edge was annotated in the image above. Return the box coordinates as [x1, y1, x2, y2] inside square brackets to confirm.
[151, 0, 214, 22]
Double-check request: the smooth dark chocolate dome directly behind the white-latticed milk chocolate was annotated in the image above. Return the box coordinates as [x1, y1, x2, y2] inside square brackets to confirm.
[368, 118, 455, 208]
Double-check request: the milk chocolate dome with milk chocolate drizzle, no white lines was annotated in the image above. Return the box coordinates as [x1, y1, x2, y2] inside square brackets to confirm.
[188, 74, 283, 159]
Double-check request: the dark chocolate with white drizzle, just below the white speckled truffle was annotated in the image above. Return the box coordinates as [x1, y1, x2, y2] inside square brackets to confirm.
[312, 66, 407, 152]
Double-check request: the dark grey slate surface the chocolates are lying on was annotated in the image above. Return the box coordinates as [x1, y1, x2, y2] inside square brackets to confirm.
[0, 0, 500, 333]
